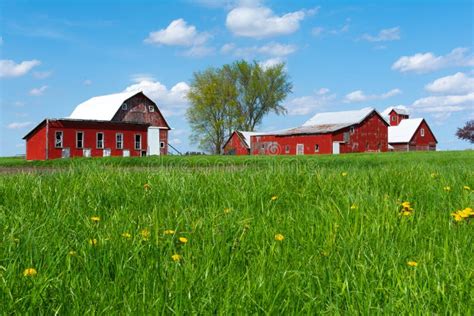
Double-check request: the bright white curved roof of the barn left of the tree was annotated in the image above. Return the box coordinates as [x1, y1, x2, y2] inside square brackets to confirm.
[69, 91, 139, 121]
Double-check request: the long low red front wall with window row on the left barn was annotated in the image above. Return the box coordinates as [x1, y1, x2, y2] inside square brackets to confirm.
[48, 121, 148, 159]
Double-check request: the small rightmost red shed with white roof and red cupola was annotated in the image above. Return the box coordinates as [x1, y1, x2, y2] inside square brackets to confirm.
[383, 107, 438, 151]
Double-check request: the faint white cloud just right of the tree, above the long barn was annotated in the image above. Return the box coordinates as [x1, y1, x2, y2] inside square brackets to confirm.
[285, 88, 336, 115]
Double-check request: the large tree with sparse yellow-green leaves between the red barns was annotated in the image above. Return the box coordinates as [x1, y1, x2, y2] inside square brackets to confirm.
[186, 60, 292, 154]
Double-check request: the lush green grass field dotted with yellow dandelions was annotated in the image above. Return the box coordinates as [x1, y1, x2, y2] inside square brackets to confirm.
[0, 152, 474, 315]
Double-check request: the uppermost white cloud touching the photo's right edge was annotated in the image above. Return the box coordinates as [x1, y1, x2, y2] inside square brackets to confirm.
[392, 47, 474, 73]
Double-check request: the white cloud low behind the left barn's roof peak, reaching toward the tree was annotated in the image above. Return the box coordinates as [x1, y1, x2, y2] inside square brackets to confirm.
[124, 80, 189, 117]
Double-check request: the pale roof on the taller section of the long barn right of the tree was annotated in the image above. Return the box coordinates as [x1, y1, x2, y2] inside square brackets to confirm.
[303, 107, 374, 126]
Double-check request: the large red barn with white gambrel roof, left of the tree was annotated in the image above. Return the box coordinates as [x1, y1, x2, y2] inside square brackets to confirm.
[23, 92, 170, 160]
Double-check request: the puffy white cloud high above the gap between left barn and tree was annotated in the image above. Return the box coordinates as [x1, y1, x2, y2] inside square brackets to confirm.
[145, 19, 209, 46]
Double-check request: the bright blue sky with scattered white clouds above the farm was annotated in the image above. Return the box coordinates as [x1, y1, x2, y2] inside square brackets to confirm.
[0, 0, 474, 156]
